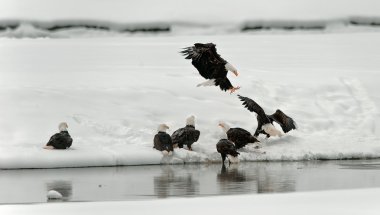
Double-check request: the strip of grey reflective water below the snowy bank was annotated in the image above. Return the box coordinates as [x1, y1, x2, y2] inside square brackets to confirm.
[0, 160, 380, 204]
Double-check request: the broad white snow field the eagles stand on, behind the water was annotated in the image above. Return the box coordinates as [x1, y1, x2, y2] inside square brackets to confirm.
[0, 32, 380, 168]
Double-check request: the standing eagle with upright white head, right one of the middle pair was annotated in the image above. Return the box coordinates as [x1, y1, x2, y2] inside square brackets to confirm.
[172, 116, 200, 151]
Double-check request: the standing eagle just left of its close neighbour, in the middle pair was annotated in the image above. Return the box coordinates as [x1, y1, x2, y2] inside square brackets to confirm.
[153, 124, 173, 155]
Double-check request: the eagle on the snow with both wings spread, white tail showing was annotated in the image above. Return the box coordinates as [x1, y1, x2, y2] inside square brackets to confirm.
[238, 95, 297, 137]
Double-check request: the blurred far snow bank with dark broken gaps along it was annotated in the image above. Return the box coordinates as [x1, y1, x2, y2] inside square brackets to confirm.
[0, 17, 380, 38]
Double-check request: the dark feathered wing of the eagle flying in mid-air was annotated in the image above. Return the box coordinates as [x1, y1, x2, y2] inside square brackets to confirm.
[181, 43, 227, 80]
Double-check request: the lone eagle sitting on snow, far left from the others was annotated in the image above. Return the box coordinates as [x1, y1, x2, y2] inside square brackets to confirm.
[44, 122, 73, 149]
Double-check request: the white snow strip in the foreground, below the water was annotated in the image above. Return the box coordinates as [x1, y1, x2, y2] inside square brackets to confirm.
[0, 188, 380, 215]
